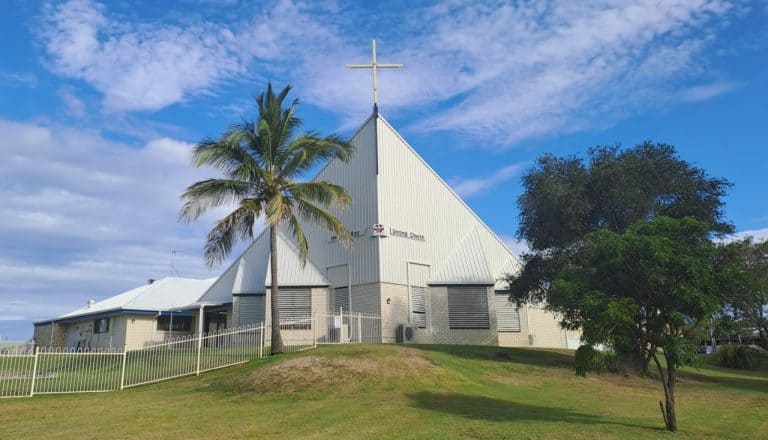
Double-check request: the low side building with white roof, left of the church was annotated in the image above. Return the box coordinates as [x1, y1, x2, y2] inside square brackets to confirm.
[34, 278, 218, 349]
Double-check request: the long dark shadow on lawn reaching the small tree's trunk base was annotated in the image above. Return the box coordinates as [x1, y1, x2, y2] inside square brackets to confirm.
[408, 392, 664, 431]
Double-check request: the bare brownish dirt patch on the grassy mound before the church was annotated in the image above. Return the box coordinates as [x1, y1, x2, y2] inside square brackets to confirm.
[235, 351, 439, 394]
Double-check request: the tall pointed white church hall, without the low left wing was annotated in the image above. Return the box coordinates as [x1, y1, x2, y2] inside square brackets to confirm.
[189, 112, 579, 347]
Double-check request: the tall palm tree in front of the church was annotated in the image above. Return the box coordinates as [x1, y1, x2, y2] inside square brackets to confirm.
[179, 83, 354, 354]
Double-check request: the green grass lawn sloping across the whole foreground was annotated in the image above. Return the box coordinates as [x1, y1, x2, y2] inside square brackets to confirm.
[0, 345, 768, 439]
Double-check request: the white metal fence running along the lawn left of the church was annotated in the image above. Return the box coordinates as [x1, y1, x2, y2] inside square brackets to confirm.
[0, 312, 381, 398]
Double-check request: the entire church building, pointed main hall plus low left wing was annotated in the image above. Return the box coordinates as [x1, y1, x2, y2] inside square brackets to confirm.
[35, 112, 580, 348]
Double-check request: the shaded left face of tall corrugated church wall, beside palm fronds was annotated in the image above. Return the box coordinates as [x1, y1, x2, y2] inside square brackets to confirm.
[303, 118, 379, 284]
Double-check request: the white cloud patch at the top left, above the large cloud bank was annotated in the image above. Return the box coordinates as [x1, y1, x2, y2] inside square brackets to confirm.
[42, 0, 244, 111]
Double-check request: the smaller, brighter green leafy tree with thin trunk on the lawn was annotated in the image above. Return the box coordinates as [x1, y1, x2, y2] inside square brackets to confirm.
[547, 216, 738, 431]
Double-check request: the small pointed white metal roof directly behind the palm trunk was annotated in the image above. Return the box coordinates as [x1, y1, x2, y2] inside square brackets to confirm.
[195, 230, 330, 305]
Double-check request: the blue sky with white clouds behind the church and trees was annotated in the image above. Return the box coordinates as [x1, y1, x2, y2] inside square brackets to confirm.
[0, 0, 768, 339]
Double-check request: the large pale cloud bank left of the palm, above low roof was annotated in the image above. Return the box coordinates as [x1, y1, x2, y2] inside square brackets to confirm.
[0, 120, 244, 319]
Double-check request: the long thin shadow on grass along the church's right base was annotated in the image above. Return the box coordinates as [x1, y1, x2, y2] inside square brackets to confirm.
[412, 345, 573, 368]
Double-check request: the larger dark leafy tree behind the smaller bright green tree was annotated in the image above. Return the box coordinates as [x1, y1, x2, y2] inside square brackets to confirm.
[509, 142, 732, 371]
